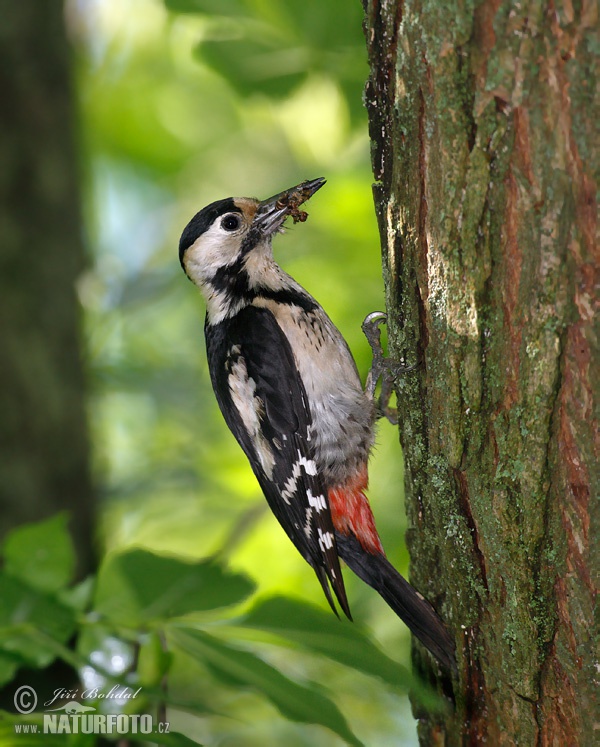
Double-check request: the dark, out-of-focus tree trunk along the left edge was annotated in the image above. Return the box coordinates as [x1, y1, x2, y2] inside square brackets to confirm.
[0, 0, 93, 573]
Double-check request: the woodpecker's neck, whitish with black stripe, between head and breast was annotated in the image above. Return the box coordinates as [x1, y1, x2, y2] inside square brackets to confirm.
[200, 238, 314, 325]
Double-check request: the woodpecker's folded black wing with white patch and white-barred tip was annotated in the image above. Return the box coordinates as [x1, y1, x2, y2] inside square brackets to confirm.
[205, 306, 350, 617]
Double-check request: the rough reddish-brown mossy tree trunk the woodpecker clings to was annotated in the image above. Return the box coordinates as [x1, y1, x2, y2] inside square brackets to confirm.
[365, 0, 600, 747]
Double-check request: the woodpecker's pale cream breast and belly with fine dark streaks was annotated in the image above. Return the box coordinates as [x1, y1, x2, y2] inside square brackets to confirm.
[253, 298, 375, 486]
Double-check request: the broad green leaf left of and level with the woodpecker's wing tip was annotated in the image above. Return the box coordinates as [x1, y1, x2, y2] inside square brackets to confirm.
[94, 549, 254, 626]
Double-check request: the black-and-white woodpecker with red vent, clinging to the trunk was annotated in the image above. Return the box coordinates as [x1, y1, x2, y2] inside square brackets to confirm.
[179, 178, 456, 671]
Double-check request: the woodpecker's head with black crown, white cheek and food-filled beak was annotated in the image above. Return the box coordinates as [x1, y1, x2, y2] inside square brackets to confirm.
[179, 178, 325, 314]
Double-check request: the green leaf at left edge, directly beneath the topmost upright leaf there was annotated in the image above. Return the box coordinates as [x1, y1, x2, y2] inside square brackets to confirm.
[0, 573, 75, 667]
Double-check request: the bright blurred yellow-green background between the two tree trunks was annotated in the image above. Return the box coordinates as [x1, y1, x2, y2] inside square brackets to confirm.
[67, 0, 416, 747]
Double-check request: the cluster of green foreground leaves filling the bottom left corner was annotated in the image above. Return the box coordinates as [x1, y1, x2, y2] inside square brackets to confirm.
[0, 516, 427, 747]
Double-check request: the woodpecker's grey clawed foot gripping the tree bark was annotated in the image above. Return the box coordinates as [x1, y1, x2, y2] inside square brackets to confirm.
[362, 311, 417, 425]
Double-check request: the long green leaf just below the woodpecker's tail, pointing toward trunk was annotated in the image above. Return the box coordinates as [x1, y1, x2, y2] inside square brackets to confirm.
[241, 597, 415, 691]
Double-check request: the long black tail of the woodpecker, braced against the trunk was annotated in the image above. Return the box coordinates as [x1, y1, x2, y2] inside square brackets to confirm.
[336, 532, 456, 673]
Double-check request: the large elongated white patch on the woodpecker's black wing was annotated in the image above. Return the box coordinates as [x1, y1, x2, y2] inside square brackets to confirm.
[227, 354, 275, 479]
